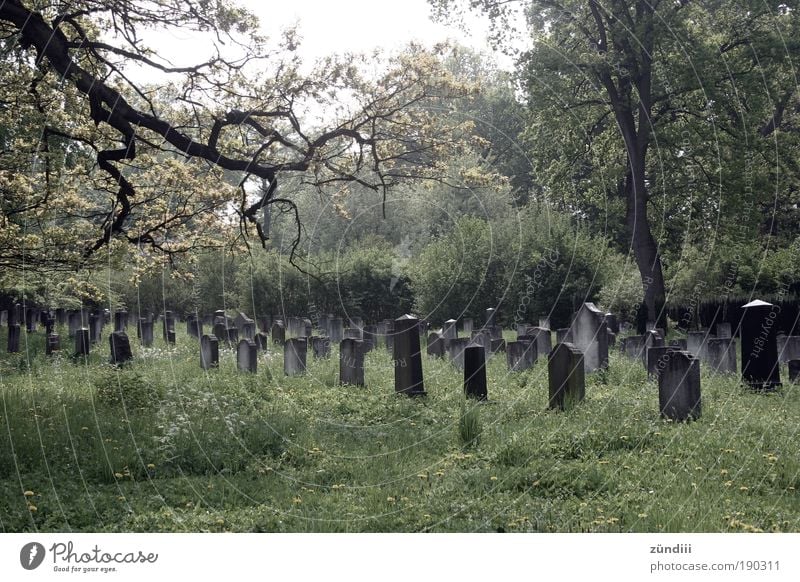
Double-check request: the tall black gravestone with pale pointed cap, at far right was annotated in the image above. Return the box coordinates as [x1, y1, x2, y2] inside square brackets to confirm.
[740, 299, 781, 390]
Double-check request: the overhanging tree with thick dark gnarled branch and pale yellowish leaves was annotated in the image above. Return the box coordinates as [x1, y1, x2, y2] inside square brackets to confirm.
[0, 0, 467, 278]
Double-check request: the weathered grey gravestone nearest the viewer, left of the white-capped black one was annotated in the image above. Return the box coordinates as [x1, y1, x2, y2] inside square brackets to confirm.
[658, 350, 701, 421]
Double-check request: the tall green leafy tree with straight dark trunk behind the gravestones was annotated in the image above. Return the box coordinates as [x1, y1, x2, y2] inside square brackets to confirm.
[432, 0, 798, 321]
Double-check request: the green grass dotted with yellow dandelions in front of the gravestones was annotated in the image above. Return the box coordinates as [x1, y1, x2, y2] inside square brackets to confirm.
[0, 330, 800, 532]
